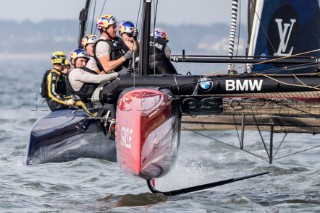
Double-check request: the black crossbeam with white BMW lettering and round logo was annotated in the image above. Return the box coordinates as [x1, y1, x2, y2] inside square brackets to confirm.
[120, 73, 320, 95]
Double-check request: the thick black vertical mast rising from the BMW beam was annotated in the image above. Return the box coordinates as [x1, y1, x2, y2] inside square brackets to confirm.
[139, 0, 152, 75]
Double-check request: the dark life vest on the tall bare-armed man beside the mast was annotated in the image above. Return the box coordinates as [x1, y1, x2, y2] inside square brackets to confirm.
[93, 37, 130, 72]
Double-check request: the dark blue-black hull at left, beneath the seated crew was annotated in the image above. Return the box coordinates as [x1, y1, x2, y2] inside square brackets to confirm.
[26, 110, 116, 165]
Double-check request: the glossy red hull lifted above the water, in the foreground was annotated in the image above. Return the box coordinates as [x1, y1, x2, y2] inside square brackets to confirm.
[116, 88, 180, 179]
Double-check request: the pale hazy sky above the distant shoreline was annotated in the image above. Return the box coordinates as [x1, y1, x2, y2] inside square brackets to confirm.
[0, 0, 247, 25]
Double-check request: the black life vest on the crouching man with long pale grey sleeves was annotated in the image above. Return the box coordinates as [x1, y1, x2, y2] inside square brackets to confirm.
[66, 67, 98, 103]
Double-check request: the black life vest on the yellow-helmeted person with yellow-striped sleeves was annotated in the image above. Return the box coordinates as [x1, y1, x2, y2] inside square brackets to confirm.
[40, 69, 66, 98]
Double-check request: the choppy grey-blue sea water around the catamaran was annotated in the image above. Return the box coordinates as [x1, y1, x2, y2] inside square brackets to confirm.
[0, 60, 320, 212]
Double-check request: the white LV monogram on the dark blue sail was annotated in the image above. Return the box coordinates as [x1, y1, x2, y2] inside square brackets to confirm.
[274, 19, 296, 56]
